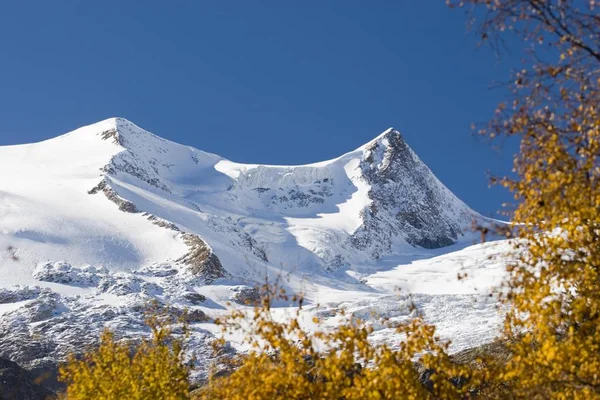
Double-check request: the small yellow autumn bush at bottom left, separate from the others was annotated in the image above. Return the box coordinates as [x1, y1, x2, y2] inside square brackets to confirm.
[60, 317, 190, 400]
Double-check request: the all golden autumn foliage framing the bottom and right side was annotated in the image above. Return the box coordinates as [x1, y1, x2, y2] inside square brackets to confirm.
[61, 0, 600, 399]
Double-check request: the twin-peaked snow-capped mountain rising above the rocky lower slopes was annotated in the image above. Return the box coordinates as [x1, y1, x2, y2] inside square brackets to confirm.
[0, 118, 480, 280]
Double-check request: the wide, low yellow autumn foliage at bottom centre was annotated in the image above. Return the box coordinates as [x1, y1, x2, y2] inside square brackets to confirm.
[194, 297, 469, 400]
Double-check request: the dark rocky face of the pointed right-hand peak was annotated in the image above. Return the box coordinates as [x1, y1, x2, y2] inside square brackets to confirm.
[351, 130, 473, 258]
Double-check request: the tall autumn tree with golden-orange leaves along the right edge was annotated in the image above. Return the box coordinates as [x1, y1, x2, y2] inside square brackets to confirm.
[450, 0, 600, 399]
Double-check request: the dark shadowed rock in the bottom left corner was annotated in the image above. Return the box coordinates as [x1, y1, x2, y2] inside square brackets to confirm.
[0, 358, 56, 400]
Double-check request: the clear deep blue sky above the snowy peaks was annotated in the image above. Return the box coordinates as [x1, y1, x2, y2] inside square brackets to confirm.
[0, 0, 511, 215]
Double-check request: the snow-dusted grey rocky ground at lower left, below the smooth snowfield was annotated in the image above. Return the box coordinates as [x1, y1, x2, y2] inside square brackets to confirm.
[0, 262, 218, 386]
